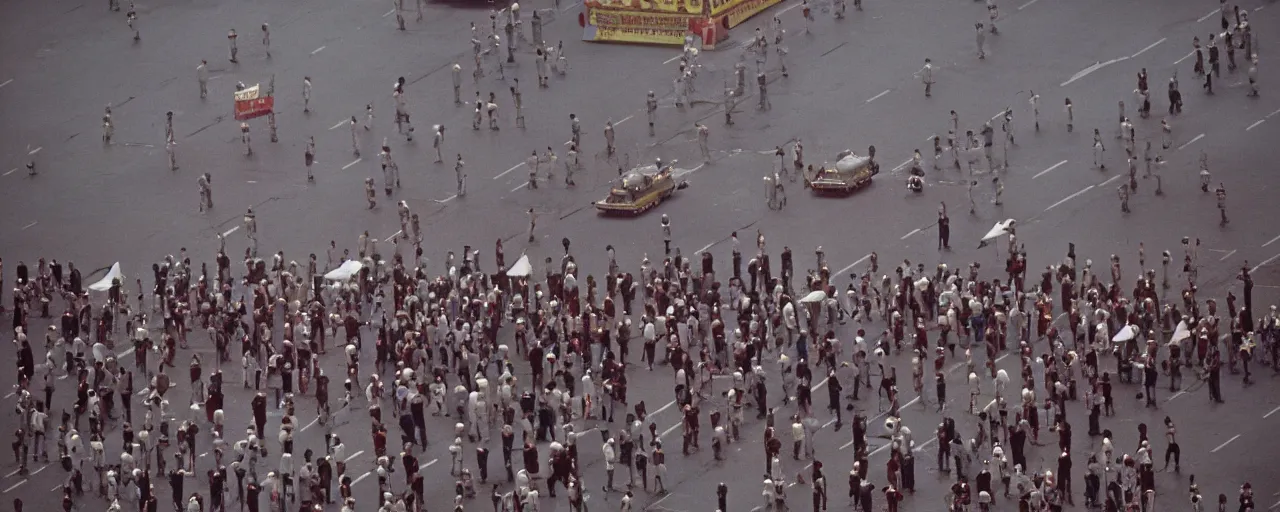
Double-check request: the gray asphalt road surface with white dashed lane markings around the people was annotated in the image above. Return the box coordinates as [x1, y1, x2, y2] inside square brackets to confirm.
[0, 0, 1280, 511]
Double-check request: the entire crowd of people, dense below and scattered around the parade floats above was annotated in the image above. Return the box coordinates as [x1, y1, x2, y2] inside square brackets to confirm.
[0, 0, 1280, 512]
